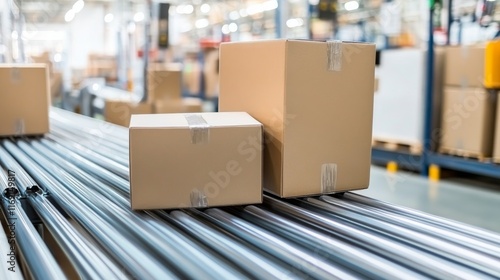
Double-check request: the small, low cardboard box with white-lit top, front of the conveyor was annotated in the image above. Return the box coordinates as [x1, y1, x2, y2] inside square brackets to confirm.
[129, 112, 262, 209]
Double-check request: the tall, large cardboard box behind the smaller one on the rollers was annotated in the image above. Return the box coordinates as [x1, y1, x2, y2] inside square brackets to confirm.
[219, 40, 375, 197]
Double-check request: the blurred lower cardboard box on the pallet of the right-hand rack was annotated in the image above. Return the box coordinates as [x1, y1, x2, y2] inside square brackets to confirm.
[440, 87, 495, 158]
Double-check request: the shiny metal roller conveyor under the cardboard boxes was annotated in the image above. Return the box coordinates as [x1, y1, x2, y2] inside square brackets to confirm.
[0, 108, 500, 279]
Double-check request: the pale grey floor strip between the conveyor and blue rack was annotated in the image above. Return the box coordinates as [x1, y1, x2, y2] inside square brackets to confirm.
[357, 166, 500, 233]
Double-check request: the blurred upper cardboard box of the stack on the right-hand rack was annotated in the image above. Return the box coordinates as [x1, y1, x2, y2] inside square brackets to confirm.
[444, 46, 484, 87]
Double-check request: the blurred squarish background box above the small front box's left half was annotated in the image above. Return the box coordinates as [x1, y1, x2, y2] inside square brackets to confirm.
[147, 65, 182, 102]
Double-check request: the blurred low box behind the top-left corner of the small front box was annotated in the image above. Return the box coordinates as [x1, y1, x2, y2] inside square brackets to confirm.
[104, 100, 153, 127]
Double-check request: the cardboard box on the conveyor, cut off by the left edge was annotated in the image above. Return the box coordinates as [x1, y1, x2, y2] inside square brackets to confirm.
[0, 63, 50, 136]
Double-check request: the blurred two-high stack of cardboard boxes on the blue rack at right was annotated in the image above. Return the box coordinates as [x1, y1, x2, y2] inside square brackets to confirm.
[439, 43, 496, 159]
